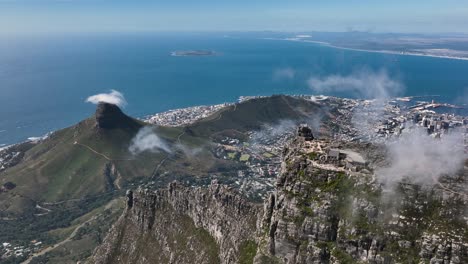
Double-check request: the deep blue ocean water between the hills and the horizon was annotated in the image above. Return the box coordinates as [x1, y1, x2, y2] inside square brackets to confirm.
[0, 33, 468, 146]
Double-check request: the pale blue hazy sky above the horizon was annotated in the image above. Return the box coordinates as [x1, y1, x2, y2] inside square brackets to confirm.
[0, 0, 468, 34]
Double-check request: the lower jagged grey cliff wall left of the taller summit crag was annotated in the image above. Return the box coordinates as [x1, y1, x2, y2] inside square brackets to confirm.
[91, 183, 260, 263]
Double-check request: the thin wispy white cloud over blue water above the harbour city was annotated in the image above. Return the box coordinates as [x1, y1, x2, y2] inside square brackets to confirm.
[307, 70, 404, 99]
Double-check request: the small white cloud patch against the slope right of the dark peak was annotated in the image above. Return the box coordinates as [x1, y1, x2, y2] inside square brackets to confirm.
[128, 126, 172, 155]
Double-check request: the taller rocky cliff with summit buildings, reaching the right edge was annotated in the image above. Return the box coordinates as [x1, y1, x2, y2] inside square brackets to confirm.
[254, 137, 468, 264]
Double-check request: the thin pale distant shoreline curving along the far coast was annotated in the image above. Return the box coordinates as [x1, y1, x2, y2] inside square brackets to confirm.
[260, 38, 468, 61]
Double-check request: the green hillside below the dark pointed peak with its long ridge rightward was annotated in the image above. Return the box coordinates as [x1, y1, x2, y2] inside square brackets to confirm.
[0, 96, 330, 262]
